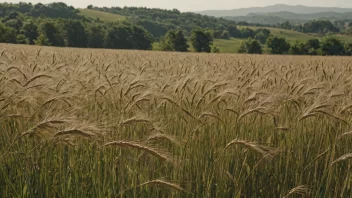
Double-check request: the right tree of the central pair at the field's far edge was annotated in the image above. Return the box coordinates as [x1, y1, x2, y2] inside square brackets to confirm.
[190, 28, 213, 53]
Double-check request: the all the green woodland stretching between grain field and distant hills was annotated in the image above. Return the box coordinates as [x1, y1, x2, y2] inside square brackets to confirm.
[0, 3, 352, 55]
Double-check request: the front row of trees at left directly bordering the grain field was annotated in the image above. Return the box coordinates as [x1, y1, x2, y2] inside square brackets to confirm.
[0, 18, 153, 50]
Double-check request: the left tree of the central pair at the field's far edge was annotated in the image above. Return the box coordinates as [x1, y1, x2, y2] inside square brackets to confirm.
[161, 29, 189, 52]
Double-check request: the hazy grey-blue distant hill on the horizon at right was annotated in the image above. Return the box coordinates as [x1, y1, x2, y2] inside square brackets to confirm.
[197, 4, 352, 17]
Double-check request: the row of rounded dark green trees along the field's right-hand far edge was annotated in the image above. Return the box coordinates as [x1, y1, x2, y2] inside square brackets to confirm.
[238, 36, 352, 56]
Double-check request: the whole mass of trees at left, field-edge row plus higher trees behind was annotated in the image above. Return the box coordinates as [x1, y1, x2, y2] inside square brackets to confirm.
[0, 3, 154, 50]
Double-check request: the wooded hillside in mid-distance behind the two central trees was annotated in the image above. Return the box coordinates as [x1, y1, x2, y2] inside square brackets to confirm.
[87, 5, 236, 40]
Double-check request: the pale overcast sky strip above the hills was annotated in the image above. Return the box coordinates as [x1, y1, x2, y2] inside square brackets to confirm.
[4, 0, 352, 11]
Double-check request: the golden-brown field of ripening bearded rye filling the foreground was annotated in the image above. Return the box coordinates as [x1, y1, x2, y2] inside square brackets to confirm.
[0, 44, 352, 198]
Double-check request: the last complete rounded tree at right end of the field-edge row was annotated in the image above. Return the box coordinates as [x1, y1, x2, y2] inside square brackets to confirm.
[321, 37, 345, 56]
